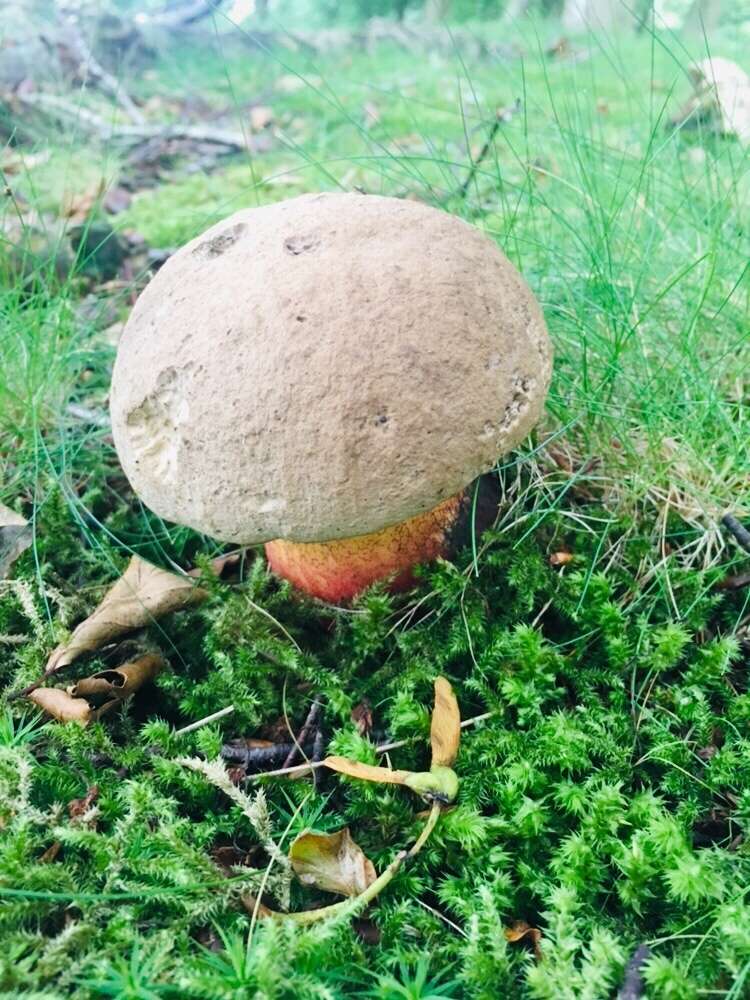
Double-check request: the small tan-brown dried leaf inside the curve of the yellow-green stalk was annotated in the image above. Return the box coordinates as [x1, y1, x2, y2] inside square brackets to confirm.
[289, 827, 376, 896]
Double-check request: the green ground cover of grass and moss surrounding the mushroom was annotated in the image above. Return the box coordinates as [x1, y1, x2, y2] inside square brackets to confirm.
[0, 9, 750, 1000]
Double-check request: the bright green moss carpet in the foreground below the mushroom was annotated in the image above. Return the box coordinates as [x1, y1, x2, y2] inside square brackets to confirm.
[0, 480, 750, 998]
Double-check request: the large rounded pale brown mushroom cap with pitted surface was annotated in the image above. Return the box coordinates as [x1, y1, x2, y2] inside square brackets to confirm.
[111, 194, 552, 543]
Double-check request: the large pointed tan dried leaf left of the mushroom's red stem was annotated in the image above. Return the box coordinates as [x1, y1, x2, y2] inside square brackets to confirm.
[44, 556, 207, 675]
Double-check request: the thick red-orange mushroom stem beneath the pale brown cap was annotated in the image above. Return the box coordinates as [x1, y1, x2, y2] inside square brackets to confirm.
[266, 475, 498, 604]
